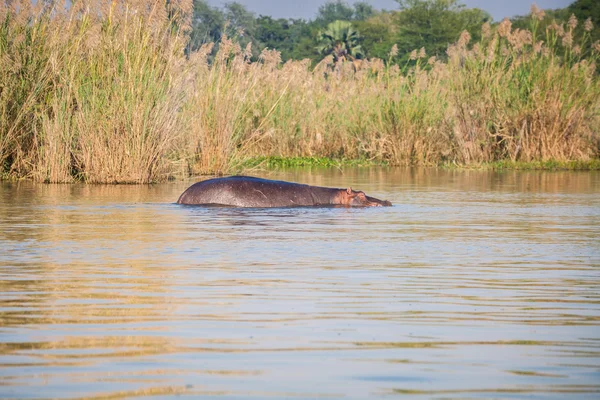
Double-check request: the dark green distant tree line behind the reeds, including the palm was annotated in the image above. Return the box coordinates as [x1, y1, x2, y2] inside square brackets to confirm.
[190, 0, 600, 65]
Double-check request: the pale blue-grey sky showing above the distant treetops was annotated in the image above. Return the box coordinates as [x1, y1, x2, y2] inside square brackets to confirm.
[208, 0, 573, 21]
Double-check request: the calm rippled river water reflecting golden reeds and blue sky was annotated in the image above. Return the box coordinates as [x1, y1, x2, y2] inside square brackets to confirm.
[0, 169, 600, 399]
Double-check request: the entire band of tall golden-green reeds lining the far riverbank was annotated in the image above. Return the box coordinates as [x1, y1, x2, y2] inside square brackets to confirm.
[0, 0, 600, 183]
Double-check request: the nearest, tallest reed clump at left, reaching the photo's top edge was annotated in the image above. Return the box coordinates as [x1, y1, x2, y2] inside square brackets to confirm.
[0, 1, 188, 183]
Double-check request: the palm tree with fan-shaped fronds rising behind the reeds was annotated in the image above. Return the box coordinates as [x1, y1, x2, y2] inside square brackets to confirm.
[317, 20, 363, 61]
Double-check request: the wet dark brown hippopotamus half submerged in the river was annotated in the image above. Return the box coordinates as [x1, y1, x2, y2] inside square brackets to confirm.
[177, 176, 392, 208]
